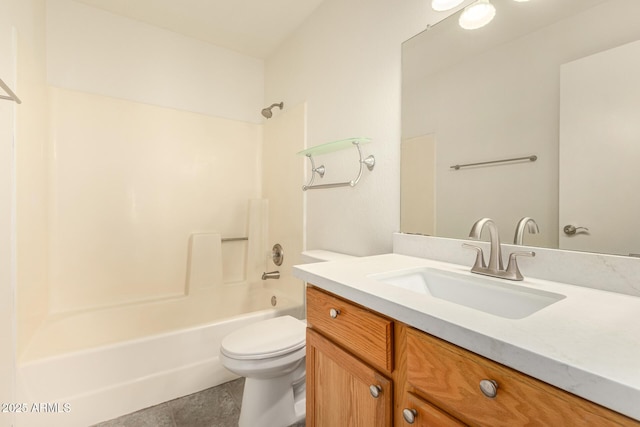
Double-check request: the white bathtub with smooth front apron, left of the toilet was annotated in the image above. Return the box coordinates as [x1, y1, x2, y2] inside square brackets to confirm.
[16, 289, 303, 427]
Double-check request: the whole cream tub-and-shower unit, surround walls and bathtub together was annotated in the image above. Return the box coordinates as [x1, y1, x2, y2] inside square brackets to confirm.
[13, 82, 306, 426]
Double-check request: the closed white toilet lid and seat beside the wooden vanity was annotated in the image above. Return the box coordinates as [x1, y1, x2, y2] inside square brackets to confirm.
[220, 316, 306, 359]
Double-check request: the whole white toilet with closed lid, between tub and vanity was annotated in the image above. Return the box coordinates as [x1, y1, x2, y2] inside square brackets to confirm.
[220, 250, 350, 427]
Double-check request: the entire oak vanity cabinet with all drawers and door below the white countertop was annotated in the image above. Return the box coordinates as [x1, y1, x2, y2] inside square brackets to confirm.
[306, 286, 640, 427]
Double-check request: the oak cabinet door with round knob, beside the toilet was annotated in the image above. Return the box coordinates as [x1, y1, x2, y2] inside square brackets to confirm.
[306, 329, 393, 427]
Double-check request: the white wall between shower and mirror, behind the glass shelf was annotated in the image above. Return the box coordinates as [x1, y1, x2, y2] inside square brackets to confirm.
[265, 0, 456, 255]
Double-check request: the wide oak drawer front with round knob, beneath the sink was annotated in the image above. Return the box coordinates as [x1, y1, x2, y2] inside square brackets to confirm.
[407, 329, 636, 426]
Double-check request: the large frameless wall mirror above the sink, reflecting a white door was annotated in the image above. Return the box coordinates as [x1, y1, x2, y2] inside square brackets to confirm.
[401, 0, 640, 256]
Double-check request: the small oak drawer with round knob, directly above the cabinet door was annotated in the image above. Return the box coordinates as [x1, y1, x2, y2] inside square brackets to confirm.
[307, 287, 393, 372]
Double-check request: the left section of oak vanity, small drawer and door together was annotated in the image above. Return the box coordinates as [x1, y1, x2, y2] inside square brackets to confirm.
[306, 288, 393, 427]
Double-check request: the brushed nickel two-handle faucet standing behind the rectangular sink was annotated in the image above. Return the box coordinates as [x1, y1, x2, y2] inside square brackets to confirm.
[462, 218, 536, 280]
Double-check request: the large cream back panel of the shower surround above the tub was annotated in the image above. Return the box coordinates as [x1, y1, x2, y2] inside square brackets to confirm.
[48, 88, 262, 313]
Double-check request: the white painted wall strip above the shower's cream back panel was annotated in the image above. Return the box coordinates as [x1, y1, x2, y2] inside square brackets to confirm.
[47, 0, 263, 123]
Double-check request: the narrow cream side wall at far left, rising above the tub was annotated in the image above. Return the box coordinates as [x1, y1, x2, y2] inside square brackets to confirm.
[2, 0, 48, 364]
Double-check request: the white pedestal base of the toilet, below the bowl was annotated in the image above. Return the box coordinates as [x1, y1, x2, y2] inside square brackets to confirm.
[238, 359, 306, 427]
